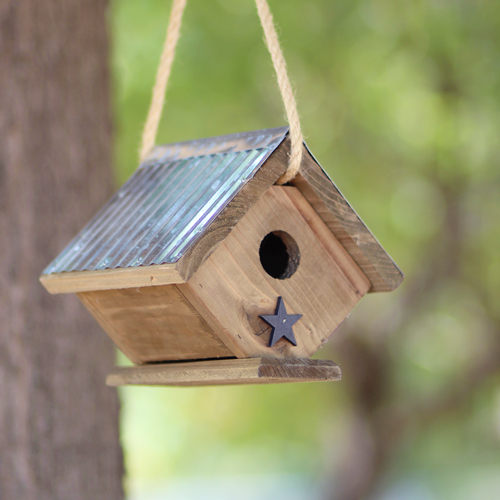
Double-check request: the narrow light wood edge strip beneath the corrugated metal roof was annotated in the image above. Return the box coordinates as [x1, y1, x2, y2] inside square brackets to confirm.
[40, 264, 185, 294]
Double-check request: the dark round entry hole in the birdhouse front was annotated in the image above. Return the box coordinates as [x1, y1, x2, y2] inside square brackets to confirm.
[259, 231, 300, 280]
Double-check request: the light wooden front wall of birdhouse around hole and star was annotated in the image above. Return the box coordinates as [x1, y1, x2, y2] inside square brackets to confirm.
[182, 186, 370, 358]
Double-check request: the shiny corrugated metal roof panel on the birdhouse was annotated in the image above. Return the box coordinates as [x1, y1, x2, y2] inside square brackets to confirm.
[43, 127, 288, 274]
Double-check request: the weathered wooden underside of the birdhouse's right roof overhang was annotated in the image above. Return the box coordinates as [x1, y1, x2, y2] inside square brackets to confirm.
[292, 147, 403, 292]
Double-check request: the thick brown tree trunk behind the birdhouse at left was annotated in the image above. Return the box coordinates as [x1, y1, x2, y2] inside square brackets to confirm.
[0, 0, 123, 500]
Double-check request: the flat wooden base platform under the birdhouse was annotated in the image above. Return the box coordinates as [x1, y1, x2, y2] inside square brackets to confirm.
[106, 358, 342, 386]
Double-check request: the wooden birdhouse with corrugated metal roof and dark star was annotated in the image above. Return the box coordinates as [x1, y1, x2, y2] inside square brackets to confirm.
[40, 127, 403, 385]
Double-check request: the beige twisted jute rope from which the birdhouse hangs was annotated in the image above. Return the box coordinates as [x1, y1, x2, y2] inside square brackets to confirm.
[140, 0, 304, 184]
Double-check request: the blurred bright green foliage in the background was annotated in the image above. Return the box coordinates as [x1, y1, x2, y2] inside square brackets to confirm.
[110, 0, 500, 499]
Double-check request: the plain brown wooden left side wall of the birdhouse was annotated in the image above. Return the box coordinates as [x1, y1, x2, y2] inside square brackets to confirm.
[78, 285, 234, 363]
